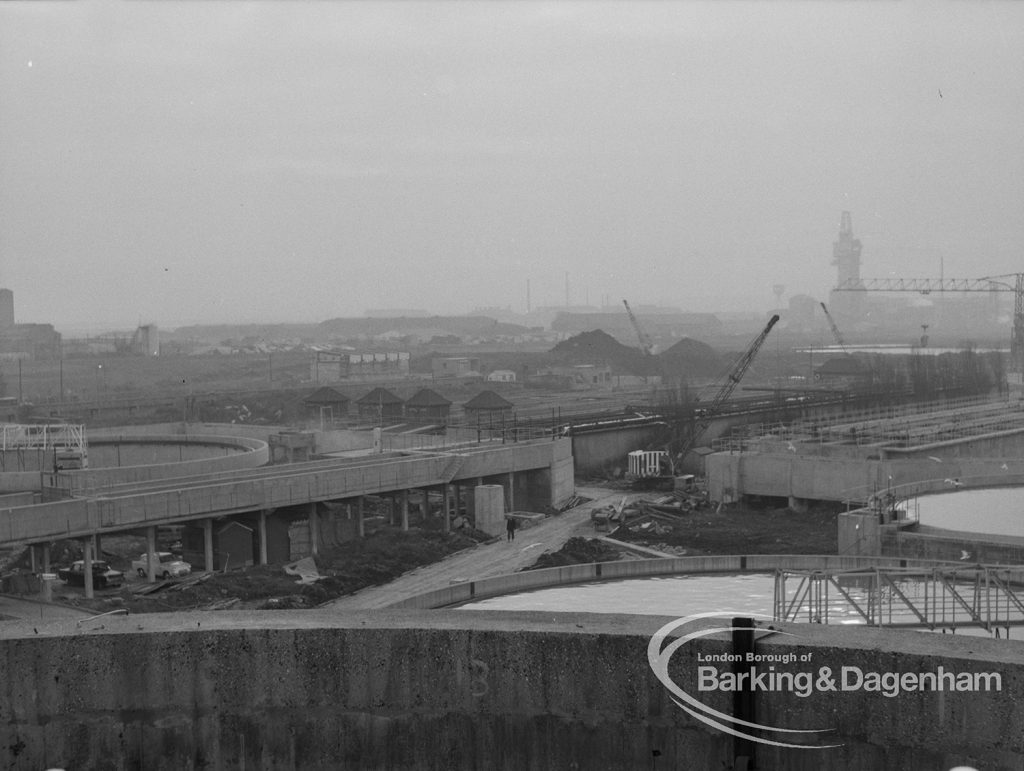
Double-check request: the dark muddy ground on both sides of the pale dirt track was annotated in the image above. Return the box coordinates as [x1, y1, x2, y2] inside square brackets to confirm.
[14, 487, 840, 612]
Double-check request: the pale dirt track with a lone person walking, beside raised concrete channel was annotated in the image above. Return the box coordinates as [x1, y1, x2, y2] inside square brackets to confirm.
[324, 487, 626, 610]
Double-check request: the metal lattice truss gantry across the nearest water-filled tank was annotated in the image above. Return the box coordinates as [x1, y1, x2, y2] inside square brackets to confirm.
[773, 565, 1024, 637]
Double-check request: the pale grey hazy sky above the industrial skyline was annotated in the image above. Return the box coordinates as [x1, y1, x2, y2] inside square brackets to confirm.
[0, 0, 1024, 331]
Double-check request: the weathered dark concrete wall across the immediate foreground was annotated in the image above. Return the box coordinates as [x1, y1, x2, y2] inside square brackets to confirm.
[0, 611, 1024, 771]
